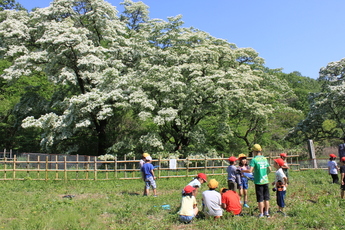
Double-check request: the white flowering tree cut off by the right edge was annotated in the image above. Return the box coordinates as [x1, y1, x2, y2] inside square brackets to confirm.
[290, 59, 345, 140]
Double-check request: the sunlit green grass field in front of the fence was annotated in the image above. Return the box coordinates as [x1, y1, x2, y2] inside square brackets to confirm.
[0, 170, 345, 230]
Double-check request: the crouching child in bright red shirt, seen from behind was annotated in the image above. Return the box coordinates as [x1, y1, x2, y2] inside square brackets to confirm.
[220, 188, 242, 215]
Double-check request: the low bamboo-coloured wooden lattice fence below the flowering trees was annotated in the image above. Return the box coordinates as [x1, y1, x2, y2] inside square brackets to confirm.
[0, 154, 299, 181]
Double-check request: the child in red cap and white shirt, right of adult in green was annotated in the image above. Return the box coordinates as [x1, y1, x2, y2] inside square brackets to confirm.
[272, 158, 287, 215]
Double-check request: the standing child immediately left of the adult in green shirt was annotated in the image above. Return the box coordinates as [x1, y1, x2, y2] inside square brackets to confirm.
[238, 153, 250, 208]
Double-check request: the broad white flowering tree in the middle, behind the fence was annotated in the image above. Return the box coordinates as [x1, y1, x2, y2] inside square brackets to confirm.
[127, 10, 291, 155]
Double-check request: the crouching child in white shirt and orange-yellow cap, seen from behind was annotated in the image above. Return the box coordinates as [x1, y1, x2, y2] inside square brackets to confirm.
[202, 179, 223, 219]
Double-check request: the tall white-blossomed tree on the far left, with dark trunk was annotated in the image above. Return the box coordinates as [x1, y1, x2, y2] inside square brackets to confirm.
[0, 0, 148, 155]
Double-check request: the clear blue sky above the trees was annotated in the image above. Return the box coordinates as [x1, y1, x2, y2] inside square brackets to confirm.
[17, 0, 345, 78]
